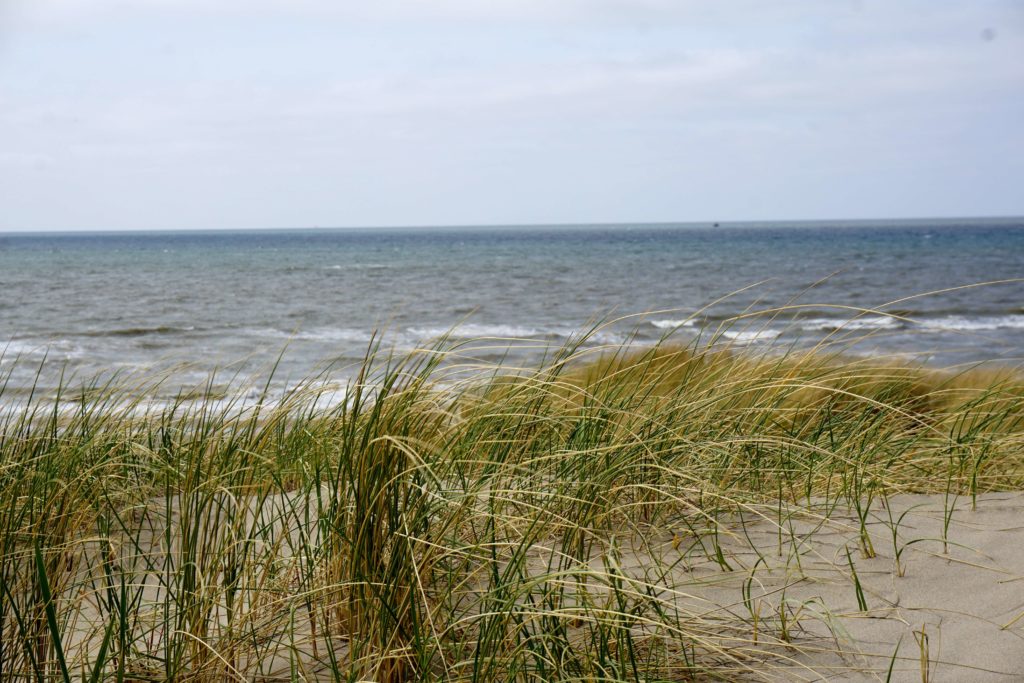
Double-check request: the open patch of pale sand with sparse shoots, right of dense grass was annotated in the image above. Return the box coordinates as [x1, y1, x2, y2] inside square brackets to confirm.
[667, 493, 1024, 682]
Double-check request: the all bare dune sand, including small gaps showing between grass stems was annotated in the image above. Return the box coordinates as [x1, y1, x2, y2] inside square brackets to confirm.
[56, 492, 1024, 683]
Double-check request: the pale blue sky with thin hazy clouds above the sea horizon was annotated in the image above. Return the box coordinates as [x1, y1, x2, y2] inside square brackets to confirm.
[0, 0, 1024, 231]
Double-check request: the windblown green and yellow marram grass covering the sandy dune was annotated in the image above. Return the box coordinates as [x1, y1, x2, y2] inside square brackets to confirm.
[0, 327, 1024, 681]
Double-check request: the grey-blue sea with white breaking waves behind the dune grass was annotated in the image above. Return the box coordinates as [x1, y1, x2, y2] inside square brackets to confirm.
[0, 218, 1024, 401]
